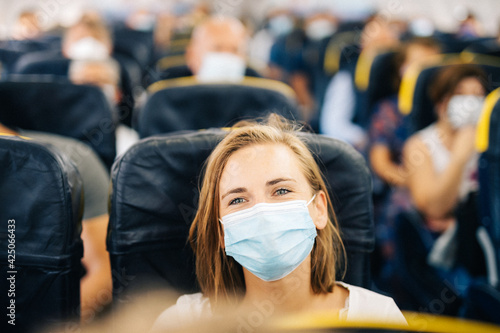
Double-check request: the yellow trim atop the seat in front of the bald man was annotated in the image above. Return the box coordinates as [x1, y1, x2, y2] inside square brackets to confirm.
[148, 76, 295, 99]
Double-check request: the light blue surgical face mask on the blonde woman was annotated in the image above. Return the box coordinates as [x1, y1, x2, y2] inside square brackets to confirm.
[220, 195, 317, 281]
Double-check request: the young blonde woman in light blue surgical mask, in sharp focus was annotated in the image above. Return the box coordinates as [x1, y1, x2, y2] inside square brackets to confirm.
[155, 116, 406, 329]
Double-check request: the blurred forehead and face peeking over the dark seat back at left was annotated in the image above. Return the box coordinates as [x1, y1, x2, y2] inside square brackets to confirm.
[69, 58, 121, 106]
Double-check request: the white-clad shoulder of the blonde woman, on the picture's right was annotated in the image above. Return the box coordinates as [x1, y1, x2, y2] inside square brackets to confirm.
[338, 282, 407, 325]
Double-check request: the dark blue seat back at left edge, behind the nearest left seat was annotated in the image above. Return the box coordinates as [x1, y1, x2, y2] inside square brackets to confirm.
[0, 81, 116, 167]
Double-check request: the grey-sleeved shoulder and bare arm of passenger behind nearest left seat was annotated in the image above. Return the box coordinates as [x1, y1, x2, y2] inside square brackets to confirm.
[0, 123, 112, 322]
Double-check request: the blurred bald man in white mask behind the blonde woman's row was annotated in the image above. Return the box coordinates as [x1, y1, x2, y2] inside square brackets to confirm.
[156, 16, 260, 82]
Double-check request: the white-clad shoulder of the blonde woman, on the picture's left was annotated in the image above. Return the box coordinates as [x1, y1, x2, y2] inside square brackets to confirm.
[152, 293, 212, 332]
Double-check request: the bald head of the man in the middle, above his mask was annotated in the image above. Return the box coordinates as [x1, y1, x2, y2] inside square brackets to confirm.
[186, 17, 248, 74]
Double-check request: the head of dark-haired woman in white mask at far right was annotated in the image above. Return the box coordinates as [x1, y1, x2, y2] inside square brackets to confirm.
[429, 64, 489, 129]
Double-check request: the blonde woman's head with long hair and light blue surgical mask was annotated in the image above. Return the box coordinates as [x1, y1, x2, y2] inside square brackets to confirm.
[190, 115, 343, 305]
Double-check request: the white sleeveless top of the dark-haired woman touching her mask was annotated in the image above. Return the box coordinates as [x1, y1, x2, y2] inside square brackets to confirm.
[418, 124, 479, 200]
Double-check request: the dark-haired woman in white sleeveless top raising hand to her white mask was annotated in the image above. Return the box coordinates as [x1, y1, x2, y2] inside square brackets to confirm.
[403, 65, 488, 232]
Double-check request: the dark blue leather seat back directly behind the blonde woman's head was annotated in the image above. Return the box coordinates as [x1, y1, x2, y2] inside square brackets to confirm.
[107, 129, 374, 302]
